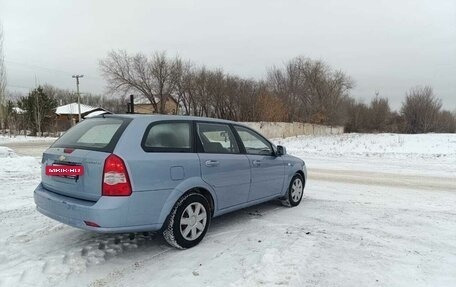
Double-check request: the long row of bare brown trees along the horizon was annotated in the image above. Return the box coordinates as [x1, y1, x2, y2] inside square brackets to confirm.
[0, 50, 456, 133]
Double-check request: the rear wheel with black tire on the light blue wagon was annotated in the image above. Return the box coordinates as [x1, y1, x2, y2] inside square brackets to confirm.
[163, 193, 211, 249]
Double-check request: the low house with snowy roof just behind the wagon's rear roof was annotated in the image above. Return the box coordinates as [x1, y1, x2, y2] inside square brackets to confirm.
[55, 103, 111, 131]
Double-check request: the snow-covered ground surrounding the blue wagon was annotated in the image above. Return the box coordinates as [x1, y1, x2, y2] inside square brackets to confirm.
[0, 134, 456, 286]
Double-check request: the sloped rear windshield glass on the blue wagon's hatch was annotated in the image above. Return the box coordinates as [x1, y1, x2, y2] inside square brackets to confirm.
[52, 118, 131, 152]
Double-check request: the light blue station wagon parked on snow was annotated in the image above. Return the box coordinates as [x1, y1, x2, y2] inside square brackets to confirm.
[34, 115, 306, 248]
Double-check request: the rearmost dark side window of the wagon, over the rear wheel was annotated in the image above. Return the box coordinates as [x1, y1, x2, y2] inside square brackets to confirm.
[142, 122, 192, 152]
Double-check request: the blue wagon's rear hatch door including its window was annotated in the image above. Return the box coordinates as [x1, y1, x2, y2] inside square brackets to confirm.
[41, 117, 131, 201]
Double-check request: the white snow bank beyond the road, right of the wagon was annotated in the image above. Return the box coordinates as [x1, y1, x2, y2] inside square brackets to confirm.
[273, 134, 456, 178]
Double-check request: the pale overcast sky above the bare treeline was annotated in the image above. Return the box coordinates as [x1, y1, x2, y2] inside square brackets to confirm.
[0, 0, 456, 110]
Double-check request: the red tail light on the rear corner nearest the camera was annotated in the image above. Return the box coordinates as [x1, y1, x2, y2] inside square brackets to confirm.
[102, 154, 131, 196]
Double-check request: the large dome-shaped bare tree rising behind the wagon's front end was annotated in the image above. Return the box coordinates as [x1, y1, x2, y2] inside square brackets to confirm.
[268, 57, 354, 124]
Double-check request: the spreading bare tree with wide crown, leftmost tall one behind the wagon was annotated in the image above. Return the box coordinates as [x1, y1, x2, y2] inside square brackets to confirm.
[99, 51, 180, 113]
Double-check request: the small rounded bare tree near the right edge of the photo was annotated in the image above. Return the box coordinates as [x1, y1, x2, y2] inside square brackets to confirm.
[401, 86, 442, 133]
